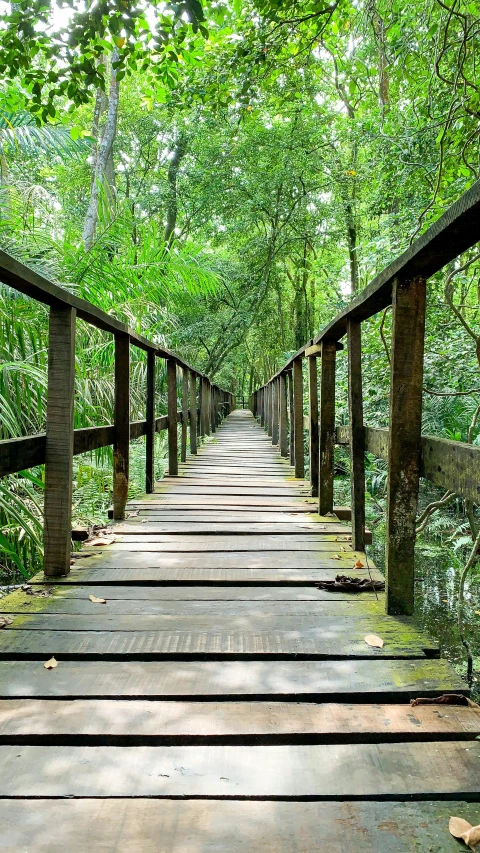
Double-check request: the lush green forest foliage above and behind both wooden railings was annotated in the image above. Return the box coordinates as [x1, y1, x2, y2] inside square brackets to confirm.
[0, 0, 480, 684]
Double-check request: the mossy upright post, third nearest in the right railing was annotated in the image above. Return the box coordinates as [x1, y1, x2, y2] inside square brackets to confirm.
[318, 341, 337, 515]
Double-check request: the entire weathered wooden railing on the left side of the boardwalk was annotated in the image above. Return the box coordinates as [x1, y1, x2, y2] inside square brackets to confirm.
[0, 252, 235, 577]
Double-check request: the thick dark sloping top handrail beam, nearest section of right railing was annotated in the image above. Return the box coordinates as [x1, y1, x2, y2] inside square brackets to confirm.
[314, 181, 480, 343]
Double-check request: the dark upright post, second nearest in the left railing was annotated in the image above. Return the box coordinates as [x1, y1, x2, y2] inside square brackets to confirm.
[113, 334, 130, 521]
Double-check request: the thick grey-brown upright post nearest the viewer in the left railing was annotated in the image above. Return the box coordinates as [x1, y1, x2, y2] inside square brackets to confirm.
[44, 306, 76, 577]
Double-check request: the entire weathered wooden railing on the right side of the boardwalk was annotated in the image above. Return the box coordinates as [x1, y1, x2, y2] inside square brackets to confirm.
[250, 181, 480, 614]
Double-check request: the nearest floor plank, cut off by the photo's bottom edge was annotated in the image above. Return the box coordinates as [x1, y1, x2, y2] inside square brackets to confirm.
[0, 798, 478, 853]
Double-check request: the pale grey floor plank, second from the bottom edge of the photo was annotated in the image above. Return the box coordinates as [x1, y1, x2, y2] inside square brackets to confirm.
[0, 741, 480, 800]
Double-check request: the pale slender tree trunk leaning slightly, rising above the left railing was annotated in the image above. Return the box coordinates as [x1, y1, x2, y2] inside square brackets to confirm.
[83, 48, 119, 252]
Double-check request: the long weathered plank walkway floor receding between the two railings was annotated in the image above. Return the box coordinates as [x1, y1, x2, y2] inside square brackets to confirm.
[0, 411, 480, 853]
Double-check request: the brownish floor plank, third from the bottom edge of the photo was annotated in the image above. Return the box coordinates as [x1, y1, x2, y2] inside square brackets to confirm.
[0, 699, 480, 746]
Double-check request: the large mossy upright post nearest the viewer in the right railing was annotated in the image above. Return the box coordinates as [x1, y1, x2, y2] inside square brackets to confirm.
[385, 277, 426, 615]
